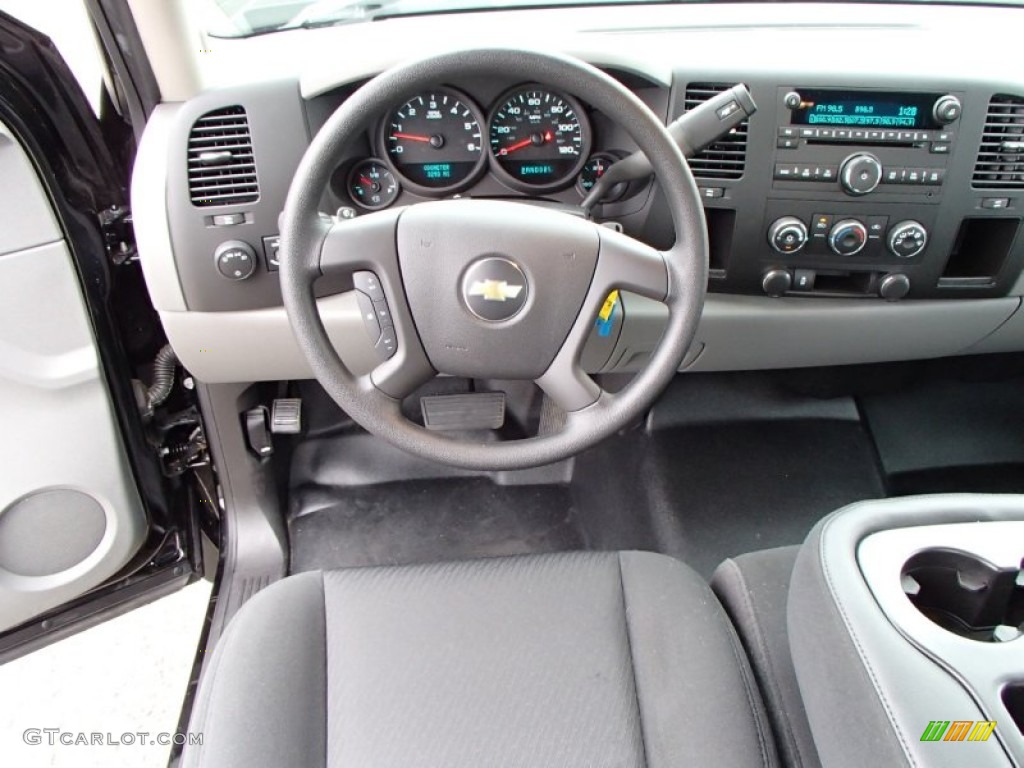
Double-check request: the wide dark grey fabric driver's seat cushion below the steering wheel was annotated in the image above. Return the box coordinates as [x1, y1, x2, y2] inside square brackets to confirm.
[183, 553, 775, 768]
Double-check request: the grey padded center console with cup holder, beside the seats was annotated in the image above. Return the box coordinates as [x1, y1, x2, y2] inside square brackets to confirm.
[788, 495, 1024, 768]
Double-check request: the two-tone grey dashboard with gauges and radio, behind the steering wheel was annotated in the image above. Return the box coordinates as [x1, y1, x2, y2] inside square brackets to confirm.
[133, 4, 1024, 381]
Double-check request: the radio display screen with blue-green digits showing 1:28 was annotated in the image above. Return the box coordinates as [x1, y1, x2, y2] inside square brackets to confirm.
[792, 89, 939, 128]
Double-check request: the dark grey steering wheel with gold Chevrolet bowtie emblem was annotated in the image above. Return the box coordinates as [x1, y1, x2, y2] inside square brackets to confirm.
[280, 49, 708, 470]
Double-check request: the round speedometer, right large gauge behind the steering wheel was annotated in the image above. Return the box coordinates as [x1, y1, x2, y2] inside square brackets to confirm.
[488, 85, 590, 191]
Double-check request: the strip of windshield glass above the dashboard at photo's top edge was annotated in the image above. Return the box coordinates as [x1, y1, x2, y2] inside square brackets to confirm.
[209, 0, 671, 37]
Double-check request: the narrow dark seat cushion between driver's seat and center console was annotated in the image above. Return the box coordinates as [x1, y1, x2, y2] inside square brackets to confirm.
[711, 547, 821, 768]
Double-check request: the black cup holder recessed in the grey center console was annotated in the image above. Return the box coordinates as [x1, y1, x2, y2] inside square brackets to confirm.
[902, 549, 1024, 642]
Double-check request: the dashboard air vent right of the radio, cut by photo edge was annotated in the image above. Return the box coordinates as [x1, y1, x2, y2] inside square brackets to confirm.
[972, 95, 1024, 189]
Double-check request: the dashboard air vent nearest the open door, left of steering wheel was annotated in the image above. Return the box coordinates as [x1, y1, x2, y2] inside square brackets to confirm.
[188, 106, 259, 208]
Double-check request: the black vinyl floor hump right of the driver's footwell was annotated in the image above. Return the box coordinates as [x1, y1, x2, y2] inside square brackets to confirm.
[643, 420, 884, 577]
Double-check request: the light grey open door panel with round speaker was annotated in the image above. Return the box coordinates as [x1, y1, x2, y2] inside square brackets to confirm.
[0, 118, 147, 632]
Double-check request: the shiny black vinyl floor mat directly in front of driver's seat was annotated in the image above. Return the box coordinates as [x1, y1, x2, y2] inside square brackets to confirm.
[289, 477, 584, 572]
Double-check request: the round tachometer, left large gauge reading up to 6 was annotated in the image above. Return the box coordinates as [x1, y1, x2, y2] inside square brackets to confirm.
[382, 88, 486, 195]
